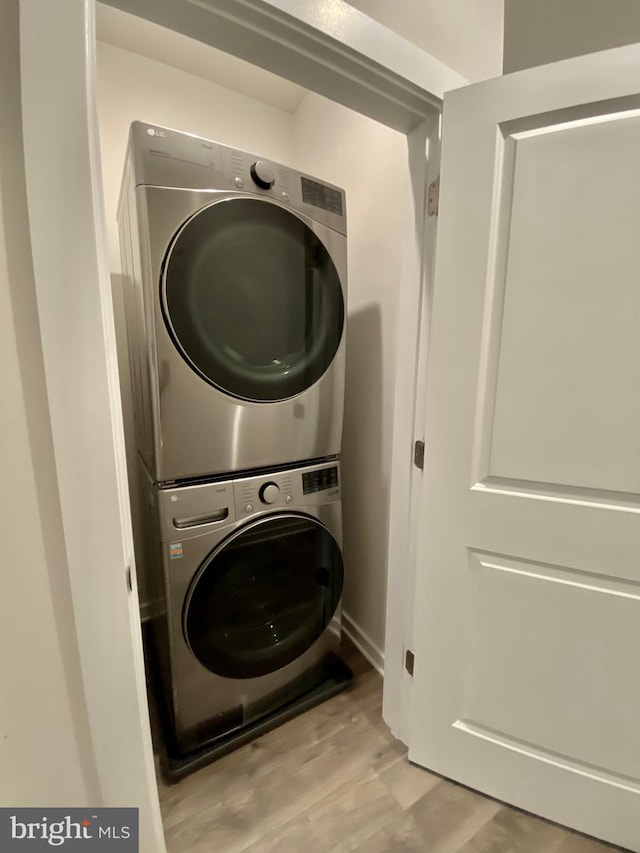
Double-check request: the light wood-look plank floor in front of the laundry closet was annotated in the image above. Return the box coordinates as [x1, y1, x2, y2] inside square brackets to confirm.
[159, 650, 616, 853]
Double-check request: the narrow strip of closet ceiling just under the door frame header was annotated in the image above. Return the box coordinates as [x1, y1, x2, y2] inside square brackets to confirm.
[96, 3, 307, 113]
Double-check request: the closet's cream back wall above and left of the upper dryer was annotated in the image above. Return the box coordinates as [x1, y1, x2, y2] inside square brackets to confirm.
[97, 42, 293, 272]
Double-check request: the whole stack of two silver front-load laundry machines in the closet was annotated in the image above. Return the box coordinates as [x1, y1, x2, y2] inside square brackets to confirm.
[118, 122, 350, 779]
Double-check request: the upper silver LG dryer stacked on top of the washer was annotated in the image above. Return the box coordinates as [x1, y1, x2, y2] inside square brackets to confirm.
[118, 122, 347, 484]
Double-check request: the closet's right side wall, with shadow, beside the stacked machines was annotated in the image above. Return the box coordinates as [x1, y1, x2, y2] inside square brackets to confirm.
[294, 93, 407, 662]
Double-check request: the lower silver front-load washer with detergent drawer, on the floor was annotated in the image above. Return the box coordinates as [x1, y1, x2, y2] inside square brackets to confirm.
[143, 461, 346, 757]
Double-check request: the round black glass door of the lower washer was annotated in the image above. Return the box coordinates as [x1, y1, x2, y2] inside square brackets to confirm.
[183, 514, 344, 678]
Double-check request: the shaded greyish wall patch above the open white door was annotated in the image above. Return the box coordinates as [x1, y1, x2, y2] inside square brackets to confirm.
[504, 0, 640, 74]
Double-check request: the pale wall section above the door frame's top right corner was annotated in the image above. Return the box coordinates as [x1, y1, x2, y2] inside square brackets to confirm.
[349, 0, 502, 83]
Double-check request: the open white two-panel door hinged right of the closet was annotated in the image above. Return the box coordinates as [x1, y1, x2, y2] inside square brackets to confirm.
[409, 41, 640, 851]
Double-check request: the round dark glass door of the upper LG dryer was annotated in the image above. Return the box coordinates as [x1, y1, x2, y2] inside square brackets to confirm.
[162, 198, 344, 402]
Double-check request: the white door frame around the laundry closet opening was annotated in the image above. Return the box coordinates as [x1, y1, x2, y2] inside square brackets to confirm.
[19, 0, 466, 850]
